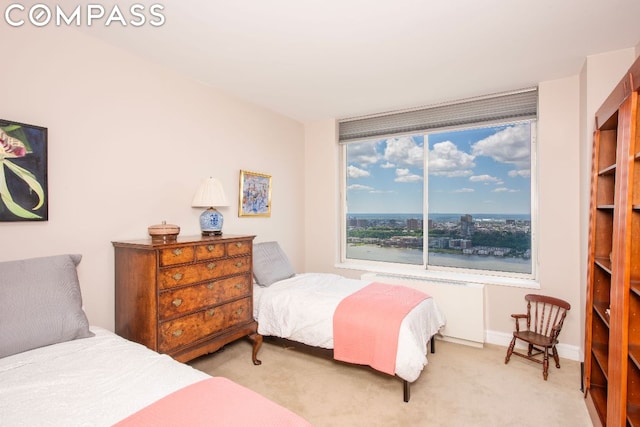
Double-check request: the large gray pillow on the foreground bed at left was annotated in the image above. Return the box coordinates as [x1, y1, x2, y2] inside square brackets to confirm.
[0, 255, 94, 357]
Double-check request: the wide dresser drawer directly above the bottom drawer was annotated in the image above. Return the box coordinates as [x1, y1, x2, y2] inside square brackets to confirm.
[158, 274, 251, 320]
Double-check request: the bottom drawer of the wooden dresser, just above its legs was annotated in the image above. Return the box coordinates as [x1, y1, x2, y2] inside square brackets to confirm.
[158, 298, 252, 353]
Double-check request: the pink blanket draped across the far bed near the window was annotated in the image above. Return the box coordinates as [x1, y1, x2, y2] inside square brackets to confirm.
[333, 283, 431, 375]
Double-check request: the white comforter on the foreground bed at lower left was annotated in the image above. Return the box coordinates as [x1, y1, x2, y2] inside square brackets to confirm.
[0, 327, 210, 426]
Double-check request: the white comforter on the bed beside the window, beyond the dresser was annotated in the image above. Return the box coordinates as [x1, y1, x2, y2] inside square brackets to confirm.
[253, 273, 445, 382]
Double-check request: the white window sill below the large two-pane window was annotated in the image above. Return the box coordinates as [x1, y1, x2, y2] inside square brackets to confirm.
[335, 262, 540, 289]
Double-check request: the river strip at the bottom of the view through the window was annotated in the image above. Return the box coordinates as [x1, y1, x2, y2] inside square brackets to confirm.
[347, 245, 531, 273]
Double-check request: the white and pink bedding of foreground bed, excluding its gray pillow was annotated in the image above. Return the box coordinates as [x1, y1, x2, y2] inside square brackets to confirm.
[0, 327, 310, 427]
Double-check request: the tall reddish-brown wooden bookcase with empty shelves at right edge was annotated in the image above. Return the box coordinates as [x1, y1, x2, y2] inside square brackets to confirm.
[584, 55, 640, 426]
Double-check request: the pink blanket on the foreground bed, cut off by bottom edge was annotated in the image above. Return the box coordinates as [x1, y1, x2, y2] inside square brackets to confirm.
[116, 377, 311, 427]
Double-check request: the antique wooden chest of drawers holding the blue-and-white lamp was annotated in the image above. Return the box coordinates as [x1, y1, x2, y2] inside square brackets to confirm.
[113, 235, 262, 365]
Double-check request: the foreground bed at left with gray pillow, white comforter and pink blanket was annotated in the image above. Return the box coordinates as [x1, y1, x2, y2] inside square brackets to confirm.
[0, 255, 310, 427]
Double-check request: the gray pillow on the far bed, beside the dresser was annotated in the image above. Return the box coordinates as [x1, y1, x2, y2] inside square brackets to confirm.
[253, 242, 296, 286]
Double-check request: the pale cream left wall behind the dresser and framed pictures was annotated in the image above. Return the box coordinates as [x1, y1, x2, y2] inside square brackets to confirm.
[0, 26, 304, 329]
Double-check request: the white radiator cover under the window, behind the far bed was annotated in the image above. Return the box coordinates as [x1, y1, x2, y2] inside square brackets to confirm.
[360, 273, 484, 347]
